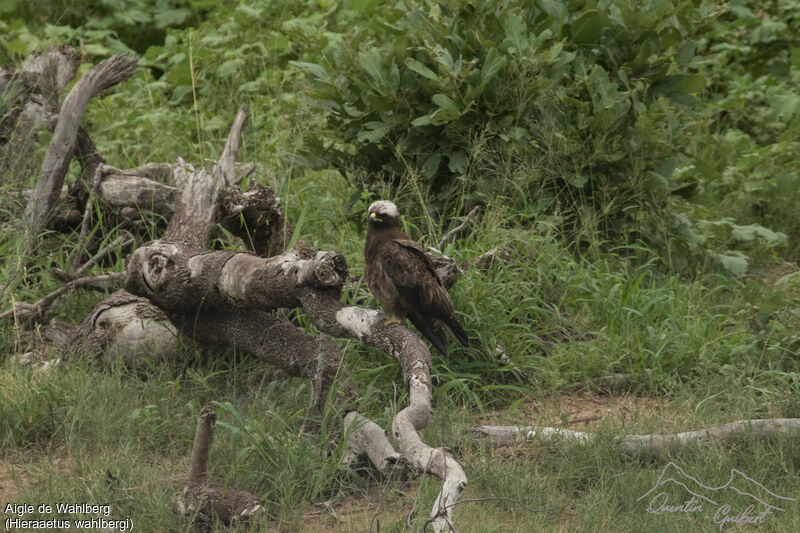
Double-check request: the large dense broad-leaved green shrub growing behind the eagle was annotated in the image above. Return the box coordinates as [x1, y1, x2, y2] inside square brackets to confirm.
[295, 0, 713, 227]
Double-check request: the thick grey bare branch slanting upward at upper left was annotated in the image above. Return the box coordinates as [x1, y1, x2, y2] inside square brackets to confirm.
[24, 56, 137, 236]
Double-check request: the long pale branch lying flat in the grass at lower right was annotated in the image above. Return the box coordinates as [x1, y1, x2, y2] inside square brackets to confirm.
[465, 418, 800, 456]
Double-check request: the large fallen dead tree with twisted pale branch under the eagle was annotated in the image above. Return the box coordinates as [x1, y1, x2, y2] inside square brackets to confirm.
[115, 108, 466, 531]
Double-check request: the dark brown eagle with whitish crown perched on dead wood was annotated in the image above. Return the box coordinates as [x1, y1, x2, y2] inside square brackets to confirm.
[364, 200, 467, 357]
